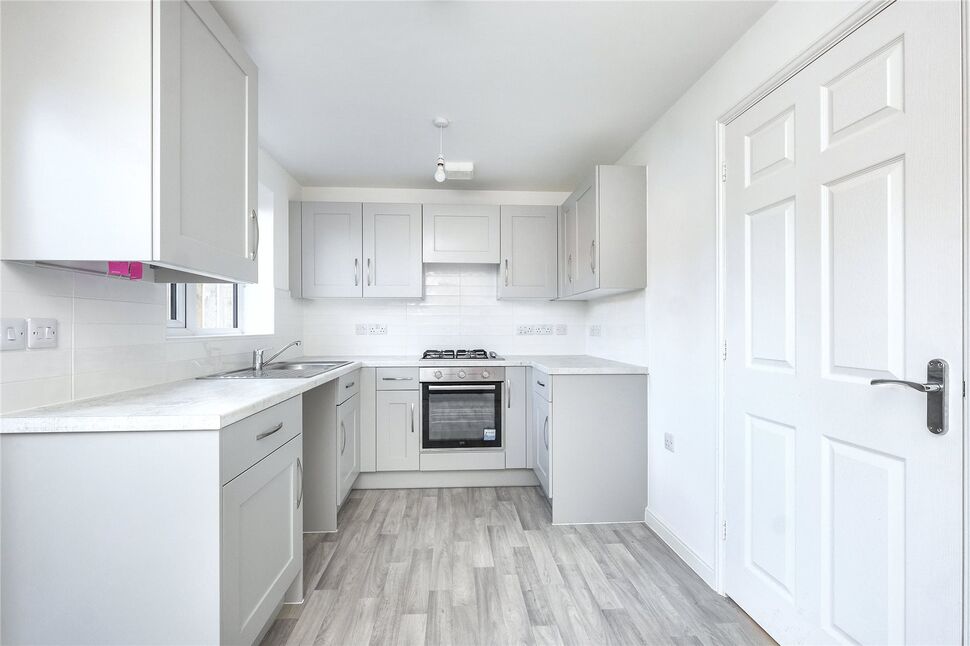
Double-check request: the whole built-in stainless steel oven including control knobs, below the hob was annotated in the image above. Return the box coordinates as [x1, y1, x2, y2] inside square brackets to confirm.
[419, 366, 505, 450]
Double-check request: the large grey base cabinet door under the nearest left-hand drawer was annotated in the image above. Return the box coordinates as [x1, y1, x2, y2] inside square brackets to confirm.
[220, 435, 303, 644]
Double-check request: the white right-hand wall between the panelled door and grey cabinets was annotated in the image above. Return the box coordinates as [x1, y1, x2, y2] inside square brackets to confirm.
[587, 1, 859, 581]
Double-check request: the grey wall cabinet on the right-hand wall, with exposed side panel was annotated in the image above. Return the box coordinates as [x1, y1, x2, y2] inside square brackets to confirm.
[559, 166, 647, 300]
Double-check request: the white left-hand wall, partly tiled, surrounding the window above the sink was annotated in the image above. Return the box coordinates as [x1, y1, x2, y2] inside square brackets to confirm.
[0, 151, 302, 412]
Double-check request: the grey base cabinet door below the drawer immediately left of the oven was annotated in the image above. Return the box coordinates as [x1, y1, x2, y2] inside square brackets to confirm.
[377, 390, 421, 471]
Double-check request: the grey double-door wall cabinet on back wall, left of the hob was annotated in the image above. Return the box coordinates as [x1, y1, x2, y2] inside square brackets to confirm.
[290, 202, 424, 298]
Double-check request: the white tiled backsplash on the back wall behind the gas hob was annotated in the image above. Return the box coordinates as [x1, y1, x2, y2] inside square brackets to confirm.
[303, 264, 586, 356]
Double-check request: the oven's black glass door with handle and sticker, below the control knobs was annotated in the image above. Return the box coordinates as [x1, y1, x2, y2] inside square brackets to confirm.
[421, 382, 502, 449]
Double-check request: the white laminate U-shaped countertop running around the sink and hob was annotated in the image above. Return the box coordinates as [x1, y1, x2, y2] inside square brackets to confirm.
[0, 355, 647, 434]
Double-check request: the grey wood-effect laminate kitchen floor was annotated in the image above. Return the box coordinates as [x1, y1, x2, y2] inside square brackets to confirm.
[263, 487, 774, 646]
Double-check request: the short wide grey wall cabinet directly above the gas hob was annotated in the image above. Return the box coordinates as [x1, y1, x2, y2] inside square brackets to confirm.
[424, 204, 501, 264]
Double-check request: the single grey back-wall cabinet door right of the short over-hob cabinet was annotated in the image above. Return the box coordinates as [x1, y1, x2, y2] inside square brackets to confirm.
[498, 206, 559, 299]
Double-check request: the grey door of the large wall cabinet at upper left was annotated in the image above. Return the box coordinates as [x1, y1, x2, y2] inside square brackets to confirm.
[152, 0, 260, 282]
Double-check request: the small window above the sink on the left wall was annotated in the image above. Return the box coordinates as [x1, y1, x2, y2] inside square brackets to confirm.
[168, 283, 240, 336]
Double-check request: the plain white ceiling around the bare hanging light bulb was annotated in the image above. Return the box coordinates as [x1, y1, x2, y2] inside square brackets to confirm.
[215, 0, 770, 190]
